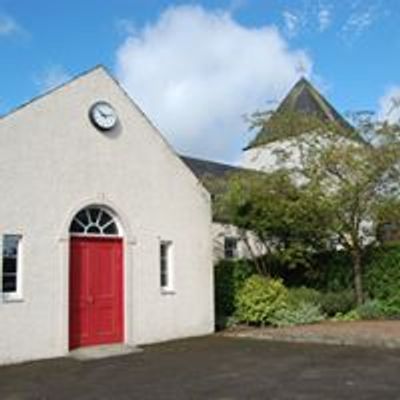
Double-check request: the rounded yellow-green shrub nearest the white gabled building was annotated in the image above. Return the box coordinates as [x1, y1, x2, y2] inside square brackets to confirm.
[236, 275, 288, 325]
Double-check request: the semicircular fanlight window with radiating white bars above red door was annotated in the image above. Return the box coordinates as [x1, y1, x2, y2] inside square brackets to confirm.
[69, 207, 119, 235]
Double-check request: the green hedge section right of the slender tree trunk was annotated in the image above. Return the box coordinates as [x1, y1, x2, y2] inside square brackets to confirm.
[364, 245, 400, 300]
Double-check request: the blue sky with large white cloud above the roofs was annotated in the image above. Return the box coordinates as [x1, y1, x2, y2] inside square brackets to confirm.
[0, 0, 400, 162]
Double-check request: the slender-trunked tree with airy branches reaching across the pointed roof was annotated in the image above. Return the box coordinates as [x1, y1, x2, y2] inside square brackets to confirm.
[248, 108, 400, 304]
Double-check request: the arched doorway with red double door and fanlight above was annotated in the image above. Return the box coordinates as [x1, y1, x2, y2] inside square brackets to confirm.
[69, 206, 124, 349]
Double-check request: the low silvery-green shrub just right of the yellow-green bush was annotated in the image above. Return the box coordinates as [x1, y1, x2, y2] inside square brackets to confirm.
[269, 302, 324, 327]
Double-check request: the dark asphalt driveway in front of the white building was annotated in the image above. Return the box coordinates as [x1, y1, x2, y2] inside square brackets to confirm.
[0, 336, 400, 400]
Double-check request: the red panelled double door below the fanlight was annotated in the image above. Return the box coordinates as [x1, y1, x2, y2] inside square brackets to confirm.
[69, 237, 124, 349]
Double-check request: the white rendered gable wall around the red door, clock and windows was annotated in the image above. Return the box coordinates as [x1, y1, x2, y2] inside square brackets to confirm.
[0, 68, 214, 363]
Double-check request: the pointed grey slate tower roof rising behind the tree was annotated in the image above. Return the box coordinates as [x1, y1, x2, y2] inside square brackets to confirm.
[244, 78, 362, 150]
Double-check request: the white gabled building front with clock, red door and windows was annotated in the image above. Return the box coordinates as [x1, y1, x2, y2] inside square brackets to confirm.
[0, 67, 214, 363]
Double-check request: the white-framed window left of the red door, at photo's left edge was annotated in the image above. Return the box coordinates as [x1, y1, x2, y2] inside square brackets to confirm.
[2, 235, 22, 300]
